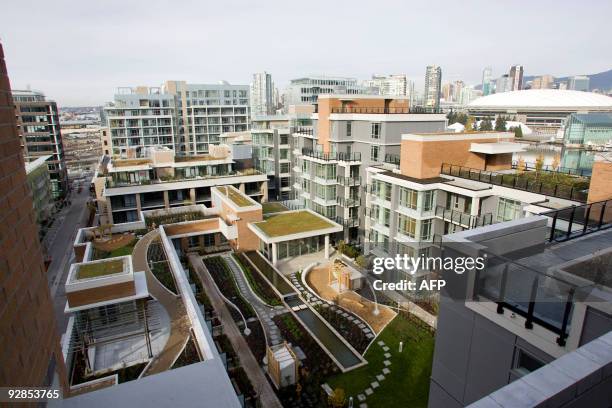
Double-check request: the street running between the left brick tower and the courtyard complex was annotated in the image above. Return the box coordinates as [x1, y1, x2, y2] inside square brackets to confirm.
[46, 179, 90, 335]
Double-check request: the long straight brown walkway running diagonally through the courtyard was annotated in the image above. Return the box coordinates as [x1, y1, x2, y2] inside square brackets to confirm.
[189, 254, 282, 408]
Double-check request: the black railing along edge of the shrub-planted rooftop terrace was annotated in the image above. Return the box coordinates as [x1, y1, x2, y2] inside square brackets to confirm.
[440, 163, 588, 202]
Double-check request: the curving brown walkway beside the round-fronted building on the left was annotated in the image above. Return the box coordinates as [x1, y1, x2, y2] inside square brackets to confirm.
[132, 230, 191, 376]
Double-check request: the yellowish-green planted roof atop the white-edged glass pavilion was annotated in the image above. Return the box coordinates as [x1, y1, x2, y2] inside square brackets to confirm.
[253, 211, 334, 237]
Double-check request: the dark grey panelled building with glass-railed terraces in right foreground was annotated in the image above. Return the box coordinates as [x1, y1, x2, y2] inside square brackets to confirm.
[429, 163, 612, 408]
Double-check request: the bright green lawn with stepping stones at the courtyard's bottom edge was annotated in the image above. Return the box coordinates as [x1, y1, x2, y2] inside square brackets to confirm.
[327, 315, 434, 408]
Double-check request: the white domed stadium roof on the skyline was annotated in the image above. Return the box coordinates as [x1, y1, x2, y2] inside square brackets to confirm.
[468, 89, 612, 110]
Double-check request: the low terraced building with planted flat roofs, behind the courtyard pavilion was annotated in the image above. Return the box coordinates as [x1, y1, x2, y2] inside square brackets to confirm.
[93, 145, 268, 224]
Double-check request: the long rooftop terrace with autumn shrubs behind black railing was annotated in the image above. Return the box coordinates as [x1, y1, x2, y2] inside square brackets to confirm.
[440, 163, 589, 202]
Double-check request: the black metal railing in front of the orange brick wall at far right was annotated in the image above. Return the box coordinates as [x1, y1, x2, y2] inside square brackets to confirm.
[540, 200, 612, 242]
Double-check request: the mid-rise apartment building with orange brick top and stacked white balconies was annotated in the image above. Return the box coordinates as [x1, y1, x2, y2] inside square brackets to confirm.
[292, 95, 446, 242]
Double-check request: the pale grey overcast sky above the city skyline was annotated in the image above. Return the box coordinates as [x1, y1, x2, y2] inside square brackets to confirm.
[0, 0, 612, 106]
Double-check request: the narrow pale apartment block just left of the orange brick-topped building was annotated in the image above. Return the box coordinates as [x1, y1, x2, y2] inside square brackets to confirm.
[251, 115, 292, 200]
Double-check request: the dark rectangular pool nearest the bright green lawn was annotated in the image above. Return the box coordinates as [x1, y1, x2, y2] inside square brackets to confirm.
[286, 296, 362, 369]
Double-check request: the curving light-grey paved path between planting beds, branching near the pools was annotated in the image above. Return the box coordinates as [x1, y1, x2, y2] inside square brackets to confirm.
[221, 253, 288, 346]
